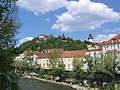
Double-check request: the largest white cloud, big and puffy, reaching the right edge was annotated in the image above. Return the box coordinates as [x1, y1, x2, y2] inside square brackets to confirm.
[52, 0, 120, 32]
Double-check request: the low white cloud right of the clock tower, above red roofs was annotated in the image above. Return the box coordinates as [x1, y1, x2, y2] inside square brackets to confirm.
[94, 34, 117, 42]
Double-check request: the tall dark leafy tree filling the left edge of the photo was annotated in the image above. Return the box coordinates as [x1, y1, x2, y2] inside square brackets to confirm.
[0, 0, 20, 90]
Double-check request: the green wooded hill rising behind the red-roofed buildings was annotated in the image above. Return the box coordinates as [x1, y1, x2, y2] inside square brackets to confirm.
[18, 34, 90, 53]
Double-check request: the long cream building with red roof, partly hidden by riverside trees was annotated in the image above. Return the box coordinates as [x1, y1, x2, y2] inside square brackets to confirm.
[37, 50, 86, 71]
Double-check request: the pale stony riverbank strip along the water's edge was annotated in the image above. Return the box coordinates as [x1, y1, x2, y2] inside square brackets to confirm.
[25, 76, 98, 90]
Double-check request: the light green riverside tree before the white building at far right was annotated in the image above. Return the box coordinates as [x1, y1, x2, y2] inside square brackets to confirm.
[102, 53, 119, 90]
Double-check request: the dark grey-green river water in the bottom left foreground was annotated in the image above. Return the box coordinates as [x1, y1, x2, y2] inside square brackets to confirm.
[19, 78, 74, 90]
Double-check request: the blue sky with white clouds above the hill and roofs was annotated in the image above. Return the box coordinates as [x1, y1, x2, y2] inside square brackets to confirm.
[17, 0, 120, 45]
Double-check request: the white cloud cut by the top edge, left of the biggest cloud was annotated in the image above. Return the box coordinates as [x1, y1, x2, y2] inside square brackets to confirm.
[17, 0, 66, 15]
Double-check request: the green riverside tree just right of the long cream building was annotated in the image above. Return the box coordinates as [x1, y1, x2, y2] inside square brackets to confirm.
[85, 55, 104, 87]
